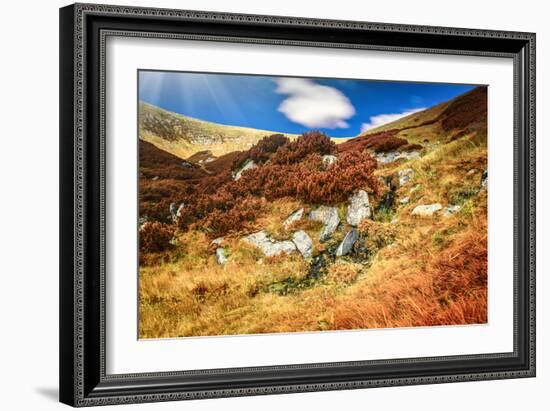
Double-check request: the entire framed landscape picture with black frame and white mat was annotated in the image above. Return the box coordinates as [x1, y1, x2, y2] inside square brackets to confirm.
[60, 4, 535, 406]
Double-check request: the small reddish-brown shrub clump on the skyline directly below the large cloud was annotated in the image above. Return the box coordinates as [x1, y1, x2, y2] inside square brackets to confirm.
[271, 131, 337, 164]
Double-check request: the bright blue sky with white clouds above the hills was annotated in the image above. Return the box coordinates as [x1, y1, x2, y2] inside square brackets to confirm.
[139, 71, 475, 137]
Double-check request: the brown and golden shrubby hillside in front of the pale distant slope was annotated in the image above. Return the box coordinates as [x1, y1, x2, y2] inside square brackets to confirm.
[139, 88, 487, 338]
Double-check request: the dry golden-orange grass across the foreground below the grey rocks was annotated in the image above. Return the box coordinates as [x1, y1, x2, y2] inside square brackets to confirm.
[140, 183, 487, 338]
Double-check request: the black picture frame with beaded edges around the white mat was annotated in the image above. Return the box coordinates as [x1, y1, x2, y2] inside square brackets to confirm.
[60, 4, 535, 406]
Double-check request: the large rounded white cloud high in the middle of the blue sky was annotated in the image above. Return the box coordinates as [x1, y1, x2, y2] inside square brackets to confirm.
[275, 78, 355, 128]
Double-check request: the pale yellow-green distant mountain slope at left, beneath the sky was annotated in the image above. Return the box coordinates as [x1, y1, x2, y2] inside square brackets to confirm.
[139, 102, 297, 158]
